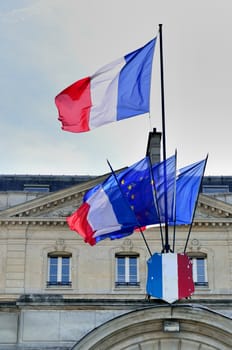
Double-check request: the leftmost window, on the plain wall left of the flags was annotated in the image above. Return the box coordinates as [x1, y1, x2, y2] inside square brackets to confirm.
[47, 254, 72, 287]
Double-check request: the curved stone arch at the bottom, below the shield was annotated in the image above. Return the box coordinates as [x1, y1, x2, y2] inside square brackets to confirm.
[72, 305, 232, 350]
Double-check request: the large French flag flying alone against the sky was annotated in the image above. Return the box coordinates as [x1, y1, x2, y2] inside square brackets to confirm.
[55, 38, 156, 133]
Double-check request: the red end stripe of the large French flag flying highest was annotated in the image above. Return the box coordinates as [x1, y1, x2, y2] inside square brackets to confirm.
[55, 77, 92, 132]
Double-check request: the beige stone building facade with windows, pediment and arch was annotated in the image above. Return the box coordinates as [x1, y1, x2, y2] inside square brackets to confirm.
[0, 132, 232, 350]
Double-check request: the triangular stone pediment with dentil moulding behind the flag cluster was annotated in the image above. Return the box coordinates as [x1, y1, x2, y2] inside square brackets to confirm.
[0, 185, 232, 228]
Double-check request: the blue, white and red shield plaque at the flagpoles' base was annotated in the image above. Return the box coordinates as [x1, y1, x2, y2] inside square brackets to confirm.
[147, 253, 194, 304]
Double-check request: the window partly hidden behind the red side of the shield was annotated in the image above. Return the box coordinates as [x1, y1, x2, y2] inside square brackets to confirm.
[190, 255, 208, 286]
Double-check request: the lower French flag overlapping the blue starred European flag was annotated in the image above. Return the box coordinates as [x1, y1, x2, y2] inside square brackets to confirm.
[66, 177, 138, 245]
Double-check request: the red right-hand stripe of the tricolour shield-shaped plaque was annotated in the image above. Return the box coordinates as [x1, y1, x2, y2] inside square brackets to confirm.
[177, 254, 194, 299]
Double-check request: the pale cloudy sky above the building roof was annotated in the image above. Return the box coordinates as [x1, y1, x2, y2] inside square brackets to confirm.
[0, 0, 232, 176]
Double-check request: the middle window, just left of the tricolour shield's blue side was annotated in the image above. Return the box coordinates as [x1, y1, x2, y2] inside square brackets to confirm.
[115, 254, 139, 287]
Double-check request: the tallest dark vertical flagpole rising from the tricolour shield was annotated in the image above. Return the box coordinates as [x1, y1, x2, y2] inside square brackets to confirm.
[159, 24, 170, 253]
